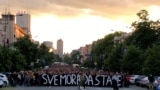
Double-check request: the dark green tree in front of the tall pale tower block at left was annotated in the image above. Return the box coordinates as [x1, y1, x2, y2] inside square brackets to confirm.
[14, 36, 38, 69]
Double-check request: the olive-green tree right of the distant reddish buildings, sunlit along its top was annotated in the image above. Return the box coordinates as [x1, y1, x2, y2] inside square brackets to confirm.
[92, 32, 123, 70]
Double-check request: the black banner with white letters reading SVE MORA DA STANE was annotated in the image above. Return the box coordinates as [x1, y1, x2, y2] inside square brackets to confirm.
[42, 74, 122, 87]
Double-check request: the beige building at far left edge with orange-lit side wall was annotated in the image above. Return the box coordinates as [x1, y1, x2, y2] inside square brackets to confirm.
[0, 13, 25, 46]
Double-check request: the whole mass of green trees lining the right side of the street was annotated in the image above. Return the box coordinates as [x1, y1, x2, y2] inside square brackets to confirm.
[89, 10, 160, 75]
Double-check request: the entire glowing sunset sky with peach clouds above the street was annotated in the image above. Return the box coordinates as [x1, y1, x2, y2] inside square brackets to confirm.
[0, 0, 160, 53]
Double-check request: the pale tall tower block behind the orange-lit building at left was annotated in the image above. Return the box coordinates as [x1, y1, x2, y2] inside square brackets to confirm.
[16, 12, 31, 38]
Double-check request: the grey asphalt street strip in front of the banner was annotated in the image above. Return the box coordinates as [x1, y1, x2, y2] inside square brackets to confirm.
[0, 86, 147, 90]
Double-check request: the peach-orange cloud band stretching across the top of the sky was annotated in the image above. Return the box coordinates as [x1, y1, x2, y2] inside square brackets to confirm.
[0, 0, 160, 18]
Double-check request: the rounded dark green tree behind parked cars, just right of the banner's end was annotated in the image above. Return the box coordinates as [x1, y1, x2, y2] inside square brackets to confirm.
[121, 45, 144, 74]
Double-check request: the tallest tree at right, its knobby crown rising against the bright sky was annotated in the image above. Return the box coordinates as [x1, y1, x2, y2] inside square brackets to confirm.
[126, 10, 160, 50]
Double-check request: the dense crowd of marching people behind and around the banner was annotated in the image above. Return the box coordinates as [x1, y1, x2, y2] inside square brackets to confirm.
[4, 65, 129, 90]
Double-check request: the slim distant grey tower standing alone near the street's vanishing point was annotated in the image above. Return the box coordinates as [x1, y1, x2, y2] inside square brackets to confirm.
[57, 39, 63, 58]
